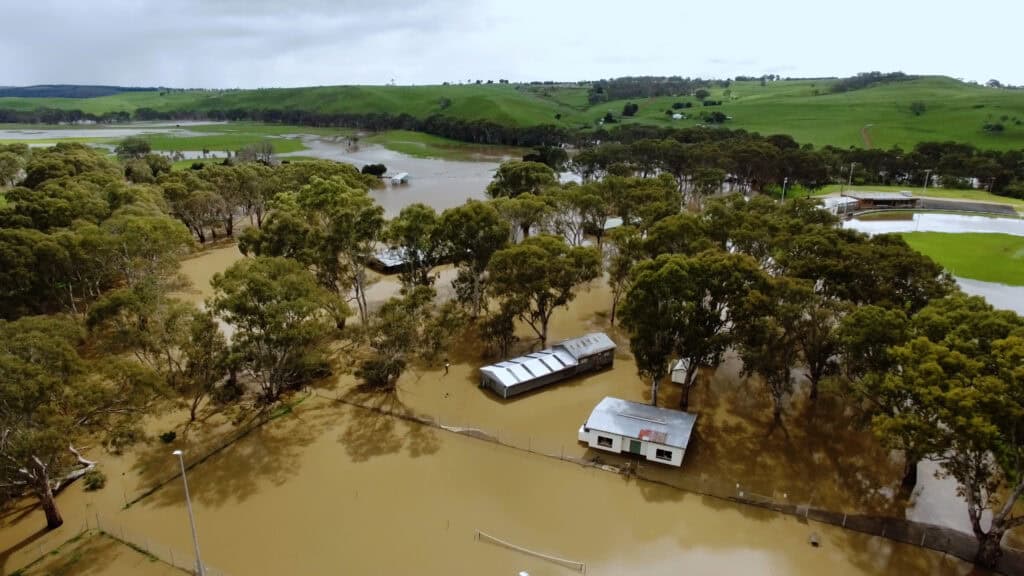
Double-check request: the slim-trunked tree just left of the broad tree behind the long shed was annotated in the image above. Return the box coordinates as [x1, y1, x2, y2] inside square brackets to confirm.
[437, 200, 511, 318]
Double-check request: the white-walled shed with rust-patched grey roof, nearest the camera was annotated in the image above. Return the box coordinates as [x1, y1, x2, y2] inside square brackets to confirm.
[579, 396, 697, 466]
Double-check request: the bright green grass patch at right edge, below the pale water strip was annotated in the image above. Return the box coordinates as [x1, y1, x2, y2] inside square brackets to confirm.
[903, 232, 1024, 286]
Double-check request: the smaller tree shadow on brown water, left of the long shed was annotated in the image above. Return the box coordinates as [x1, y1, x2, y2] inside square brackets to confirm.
[338, 386, 440, 462]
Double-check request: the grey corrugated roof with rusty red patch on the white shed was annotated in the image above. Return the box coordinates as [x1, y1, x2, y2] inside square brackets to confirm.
[584, 396, 697, 449]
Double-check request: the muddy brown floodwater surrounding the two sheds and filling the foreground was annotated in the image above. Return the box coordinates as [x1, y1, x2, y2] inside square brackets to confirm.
[0, 252, 983, 576]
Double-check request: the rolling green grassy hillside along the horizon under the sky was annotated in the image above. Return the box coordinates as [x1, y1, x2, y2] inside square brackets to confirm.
[6, 77, 1024, 150]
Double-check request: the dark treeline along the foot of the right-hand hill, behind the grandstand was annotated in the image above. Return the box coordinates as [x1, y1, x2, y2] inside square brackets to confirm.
[572, 125, 1024, 198]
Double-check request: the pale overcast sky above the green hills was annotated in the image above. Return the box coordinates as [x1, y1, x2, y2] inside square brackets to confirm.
[0, 0, 1024, 88]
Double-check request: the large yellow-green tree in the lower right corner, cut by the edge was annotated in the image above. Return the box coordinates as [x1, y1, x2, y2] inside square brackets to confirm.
[872, 336, 1024, 568]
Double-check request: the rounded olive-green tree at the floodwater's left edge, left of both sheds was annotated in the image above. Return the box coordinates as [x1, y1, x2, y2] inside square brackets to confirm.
[210, 257, 345, 401]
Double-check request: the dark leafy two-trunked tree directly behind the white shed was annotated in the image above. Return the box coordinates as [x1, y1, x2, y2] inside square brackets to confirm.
[622, 250, 766, 409]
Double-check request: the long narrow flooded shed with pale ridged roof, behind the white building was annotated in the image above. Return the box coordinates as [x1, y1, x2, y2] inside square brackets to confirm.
[480, 332, 615, 398]
